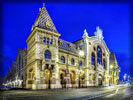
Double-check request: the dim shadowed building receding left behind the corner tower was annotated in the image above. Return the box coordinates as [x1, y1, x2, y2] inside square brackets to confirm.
[5, 49, 27, 88]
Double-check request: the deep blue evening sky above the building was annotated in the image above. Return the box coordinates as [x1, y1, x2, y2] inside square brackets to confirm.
[0, 2, 130, 79]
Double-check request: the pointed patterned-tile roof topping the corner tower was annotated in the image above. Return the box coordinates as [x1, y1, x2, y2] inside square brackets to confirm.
[34, 3, 58, 33]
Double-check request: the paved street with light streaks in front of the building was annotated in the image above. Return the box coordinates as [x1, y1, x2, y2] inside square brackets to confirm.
[0, 86, 133, 100]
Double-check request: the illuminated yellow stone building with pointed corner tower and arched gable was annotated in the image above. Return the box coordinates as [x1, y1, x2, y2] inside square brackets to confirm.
[4, 3, 118, 89]
